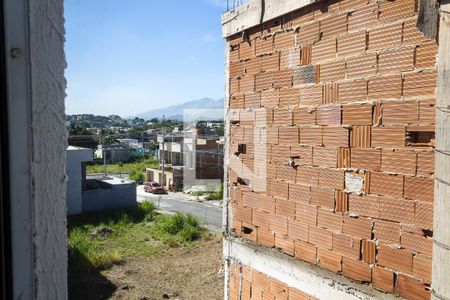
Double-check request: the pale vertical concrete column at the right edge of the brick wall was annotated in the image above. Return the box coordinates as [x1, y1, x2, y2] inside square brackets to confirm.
[432, 0, 450, 300]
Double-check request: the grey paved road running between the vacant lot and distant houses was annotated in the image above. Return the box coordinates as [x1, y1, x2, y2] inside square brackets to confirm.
[137, 185, 222, 231]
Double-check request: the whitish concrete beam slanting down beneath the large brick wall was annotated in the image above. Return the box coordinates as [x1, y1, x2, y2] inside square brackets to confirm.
[224, 237, 398, 300]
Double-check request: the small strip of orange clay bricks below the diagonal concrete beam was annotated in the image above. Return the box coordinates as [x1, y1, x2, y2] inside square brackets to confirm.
[229, 263, 316, 300]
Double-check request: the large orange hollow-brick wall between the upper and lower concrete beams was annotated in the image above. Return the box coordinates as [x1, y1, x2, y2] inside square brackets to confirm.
[223, 0, 437, 299]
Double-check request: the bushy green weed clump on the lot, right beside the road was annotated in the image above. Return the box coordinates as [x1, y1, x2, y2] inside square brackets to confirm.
[152, 213, 206, 246]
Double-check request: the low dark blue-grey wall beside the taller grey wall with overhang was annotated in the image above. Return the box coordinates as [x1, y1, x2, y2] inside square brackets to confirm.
[83, 183, 137, 212]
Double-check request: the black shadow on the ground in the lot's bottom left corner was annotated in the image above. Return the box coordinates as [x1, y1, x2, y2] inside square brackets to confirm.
[68, 249, 117, 300]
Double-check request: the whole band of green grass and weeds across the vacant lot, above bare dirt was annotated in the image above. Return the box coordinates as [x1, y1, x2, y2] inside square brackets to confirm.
[68, 201, 207, 271]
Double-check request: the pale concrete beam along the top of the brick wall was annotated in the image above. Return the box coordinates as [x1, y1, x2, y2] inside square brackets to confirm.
[222, 0, 317, 38]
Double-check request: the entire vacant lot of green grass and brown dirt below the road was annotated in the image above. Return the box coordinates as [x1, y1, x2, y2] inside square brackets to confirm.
[68, 203, 223, 300]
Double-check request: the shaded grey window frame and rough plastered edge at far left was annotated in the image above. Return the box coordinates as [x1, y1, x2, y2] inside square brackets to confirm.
[3, 0, 67, 299]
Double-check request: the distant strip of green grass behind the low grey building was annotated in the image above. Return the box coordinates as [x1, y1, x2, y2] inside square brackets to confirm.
[86, 157, 159, 176]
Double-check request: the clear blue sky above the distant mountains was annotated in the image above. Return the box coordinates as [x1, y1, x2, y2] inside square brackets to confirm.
[65, 0, 232, 117]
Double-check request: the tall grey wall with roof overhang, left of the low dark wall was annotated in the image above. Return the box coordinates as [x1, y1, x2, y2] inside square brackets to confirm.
[66, 148, 93, 215]
